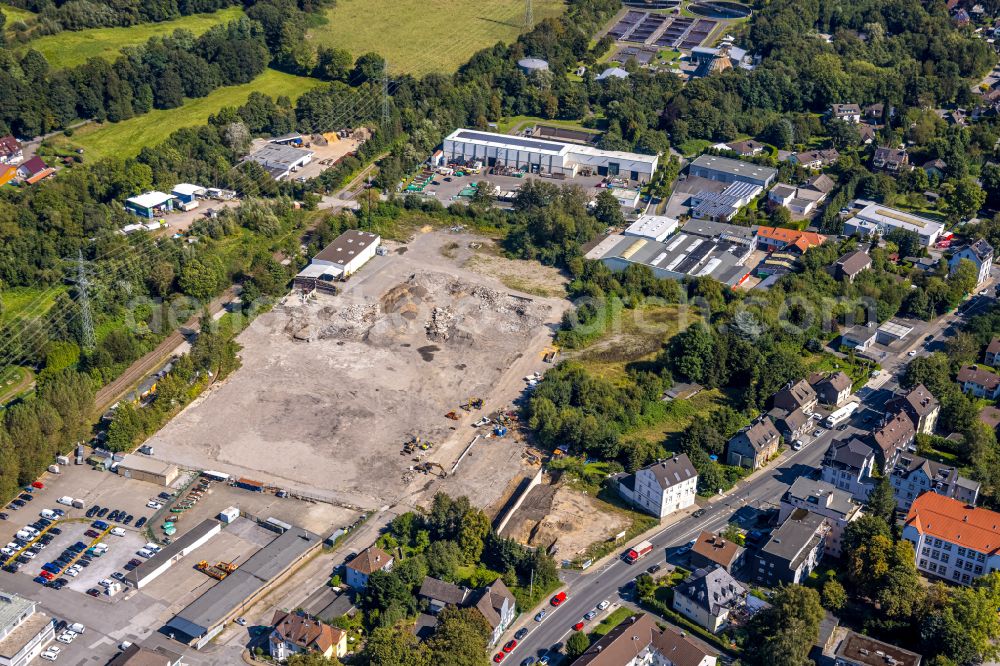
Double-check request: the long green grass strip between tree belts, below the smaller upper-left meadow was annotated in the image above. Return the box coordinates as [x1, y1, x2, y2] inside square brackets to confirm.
[58, 69, 322, 160]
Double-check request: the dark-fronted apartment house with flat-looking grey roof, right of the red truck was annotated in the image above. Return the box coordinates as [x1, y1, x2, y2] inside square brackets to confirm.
[754, 509, 830, 587]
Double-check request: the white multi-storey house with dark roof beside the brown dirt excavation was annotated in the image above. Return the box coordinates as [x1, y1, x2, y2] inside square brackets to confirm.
[618, 453, 698, 518]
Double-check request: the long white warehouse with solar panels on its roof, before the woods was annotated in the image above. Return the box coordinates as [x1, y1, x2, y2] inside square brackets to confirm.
[444, 129, 659, 181]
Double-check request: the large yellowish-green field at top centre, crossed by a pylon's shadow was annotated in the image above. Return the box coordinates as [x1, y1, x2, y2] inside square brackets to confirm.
[309, 0, 564, 75]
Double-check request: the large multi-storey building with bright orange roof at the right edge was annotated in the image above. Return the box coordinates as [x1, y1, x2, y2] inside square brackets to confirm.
[903, 493, 1000, 585]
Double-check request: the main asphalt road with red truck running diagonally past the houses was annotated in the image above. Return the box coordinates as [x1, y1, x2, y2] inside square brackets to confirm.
[508, 277, 996, 664]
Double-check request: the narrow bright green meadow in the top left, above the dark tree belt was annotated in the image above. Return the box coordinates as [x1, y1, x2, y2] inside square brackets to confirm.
[24, 7, 243, 69]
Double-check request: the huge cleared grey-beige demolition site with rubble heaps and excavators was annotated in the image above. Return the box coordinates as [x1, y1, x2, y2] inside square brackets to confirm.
[150, 231, 569, 509]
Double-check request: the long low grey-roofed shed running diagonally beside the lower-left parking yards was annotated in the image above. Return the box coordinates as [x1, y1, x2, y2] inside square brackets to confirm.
[165, 527, 323, 650]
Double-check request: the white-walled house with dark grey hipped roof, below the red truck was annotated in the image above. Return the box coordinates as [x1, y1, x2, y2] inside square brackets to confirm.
[673, 566, 747, 634]
